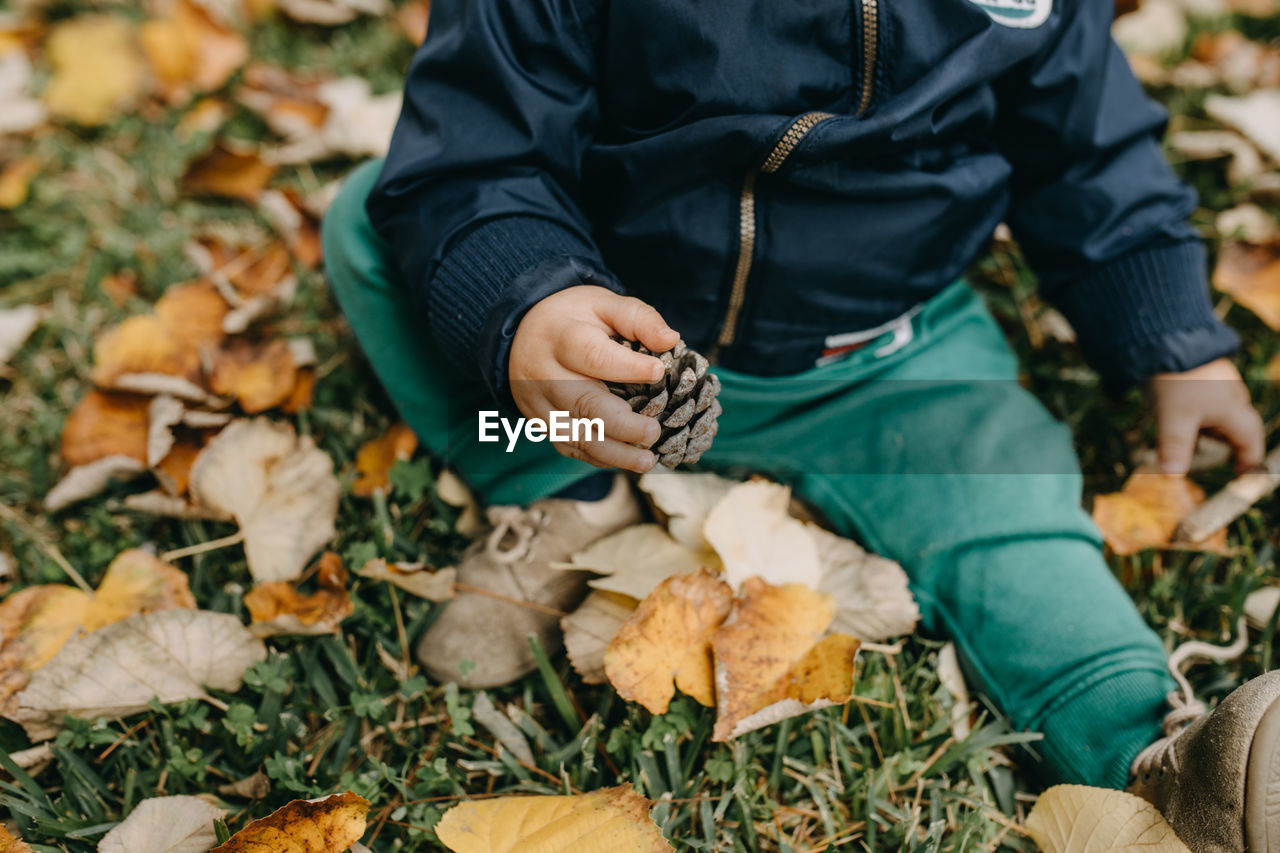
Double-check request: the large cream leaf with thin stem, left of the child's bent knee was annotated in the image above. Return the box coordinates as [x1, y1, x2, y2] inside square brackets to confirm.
[191, 418, 340, 583]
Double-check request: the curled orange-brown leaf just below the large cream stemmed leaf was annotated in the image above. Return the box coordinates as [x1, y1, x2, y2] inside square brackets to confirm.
[244, 551, 355, 637]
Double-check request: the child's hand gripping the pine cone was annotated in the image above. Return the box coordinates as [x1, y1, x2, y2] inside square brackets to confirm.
[508, 284, 680, 474]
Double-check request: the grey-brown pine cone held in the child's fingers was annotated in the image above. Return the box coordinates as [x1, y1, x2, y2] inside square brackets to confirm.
[607, 341, 721, 467]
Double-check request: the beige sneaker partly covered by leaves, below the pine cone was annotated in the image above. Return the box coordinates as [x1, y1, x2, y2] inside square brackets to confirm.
[417, 474, 640, 688]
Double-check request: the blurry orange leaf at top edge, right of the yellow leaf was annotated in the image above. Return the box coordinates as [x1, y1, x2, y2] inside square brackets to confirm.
[138, 0, 248, 104]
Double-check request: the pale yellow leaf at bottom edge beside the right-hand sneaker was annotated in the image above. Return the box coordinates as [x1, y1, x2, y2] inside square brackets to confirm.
[1027, 785, 1190, 853]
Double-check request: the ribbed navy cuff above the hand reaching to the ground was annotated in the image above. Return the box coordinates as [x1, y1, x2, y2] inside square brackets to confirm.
[1055, 241, 1240, 393]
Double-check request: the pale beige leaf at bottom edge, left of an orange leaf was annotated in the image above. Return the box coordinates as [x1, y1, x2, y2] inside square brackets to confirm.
[97, 795, 227, 853]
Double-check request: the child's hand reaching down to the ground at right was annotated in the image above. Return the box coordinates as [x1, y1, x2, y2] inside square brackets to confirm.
[1151, 359, 1266, 474]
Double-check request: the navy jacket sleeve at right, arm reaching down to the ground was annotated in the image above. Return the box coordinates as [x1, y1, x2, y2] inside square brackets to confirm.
[997, 0, 1239, 391]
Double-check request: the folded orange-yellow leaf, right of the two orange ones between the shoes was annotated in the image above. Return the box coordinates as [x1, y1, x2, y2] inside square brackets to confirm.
[710, 578, 859, 740]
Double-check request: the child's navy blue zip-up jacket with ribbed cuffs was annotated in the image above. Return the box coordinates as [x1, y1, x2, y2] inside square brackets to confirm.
[369, 0, 1238, 396]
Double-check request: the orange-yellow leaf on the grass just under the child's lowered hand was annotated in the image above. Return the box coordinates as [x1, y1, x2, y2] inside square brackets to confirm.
[1093, 469, 1226, 555]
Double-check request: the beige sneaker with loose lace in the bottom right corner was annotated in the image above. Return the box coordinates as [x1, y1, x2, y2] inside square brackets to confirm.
[1129, 622, 1280, 853]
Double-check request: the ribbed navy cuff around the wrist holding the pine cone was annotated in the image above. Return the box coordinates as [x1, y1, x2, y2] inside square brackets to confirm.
[426, 216, 621, 403]
